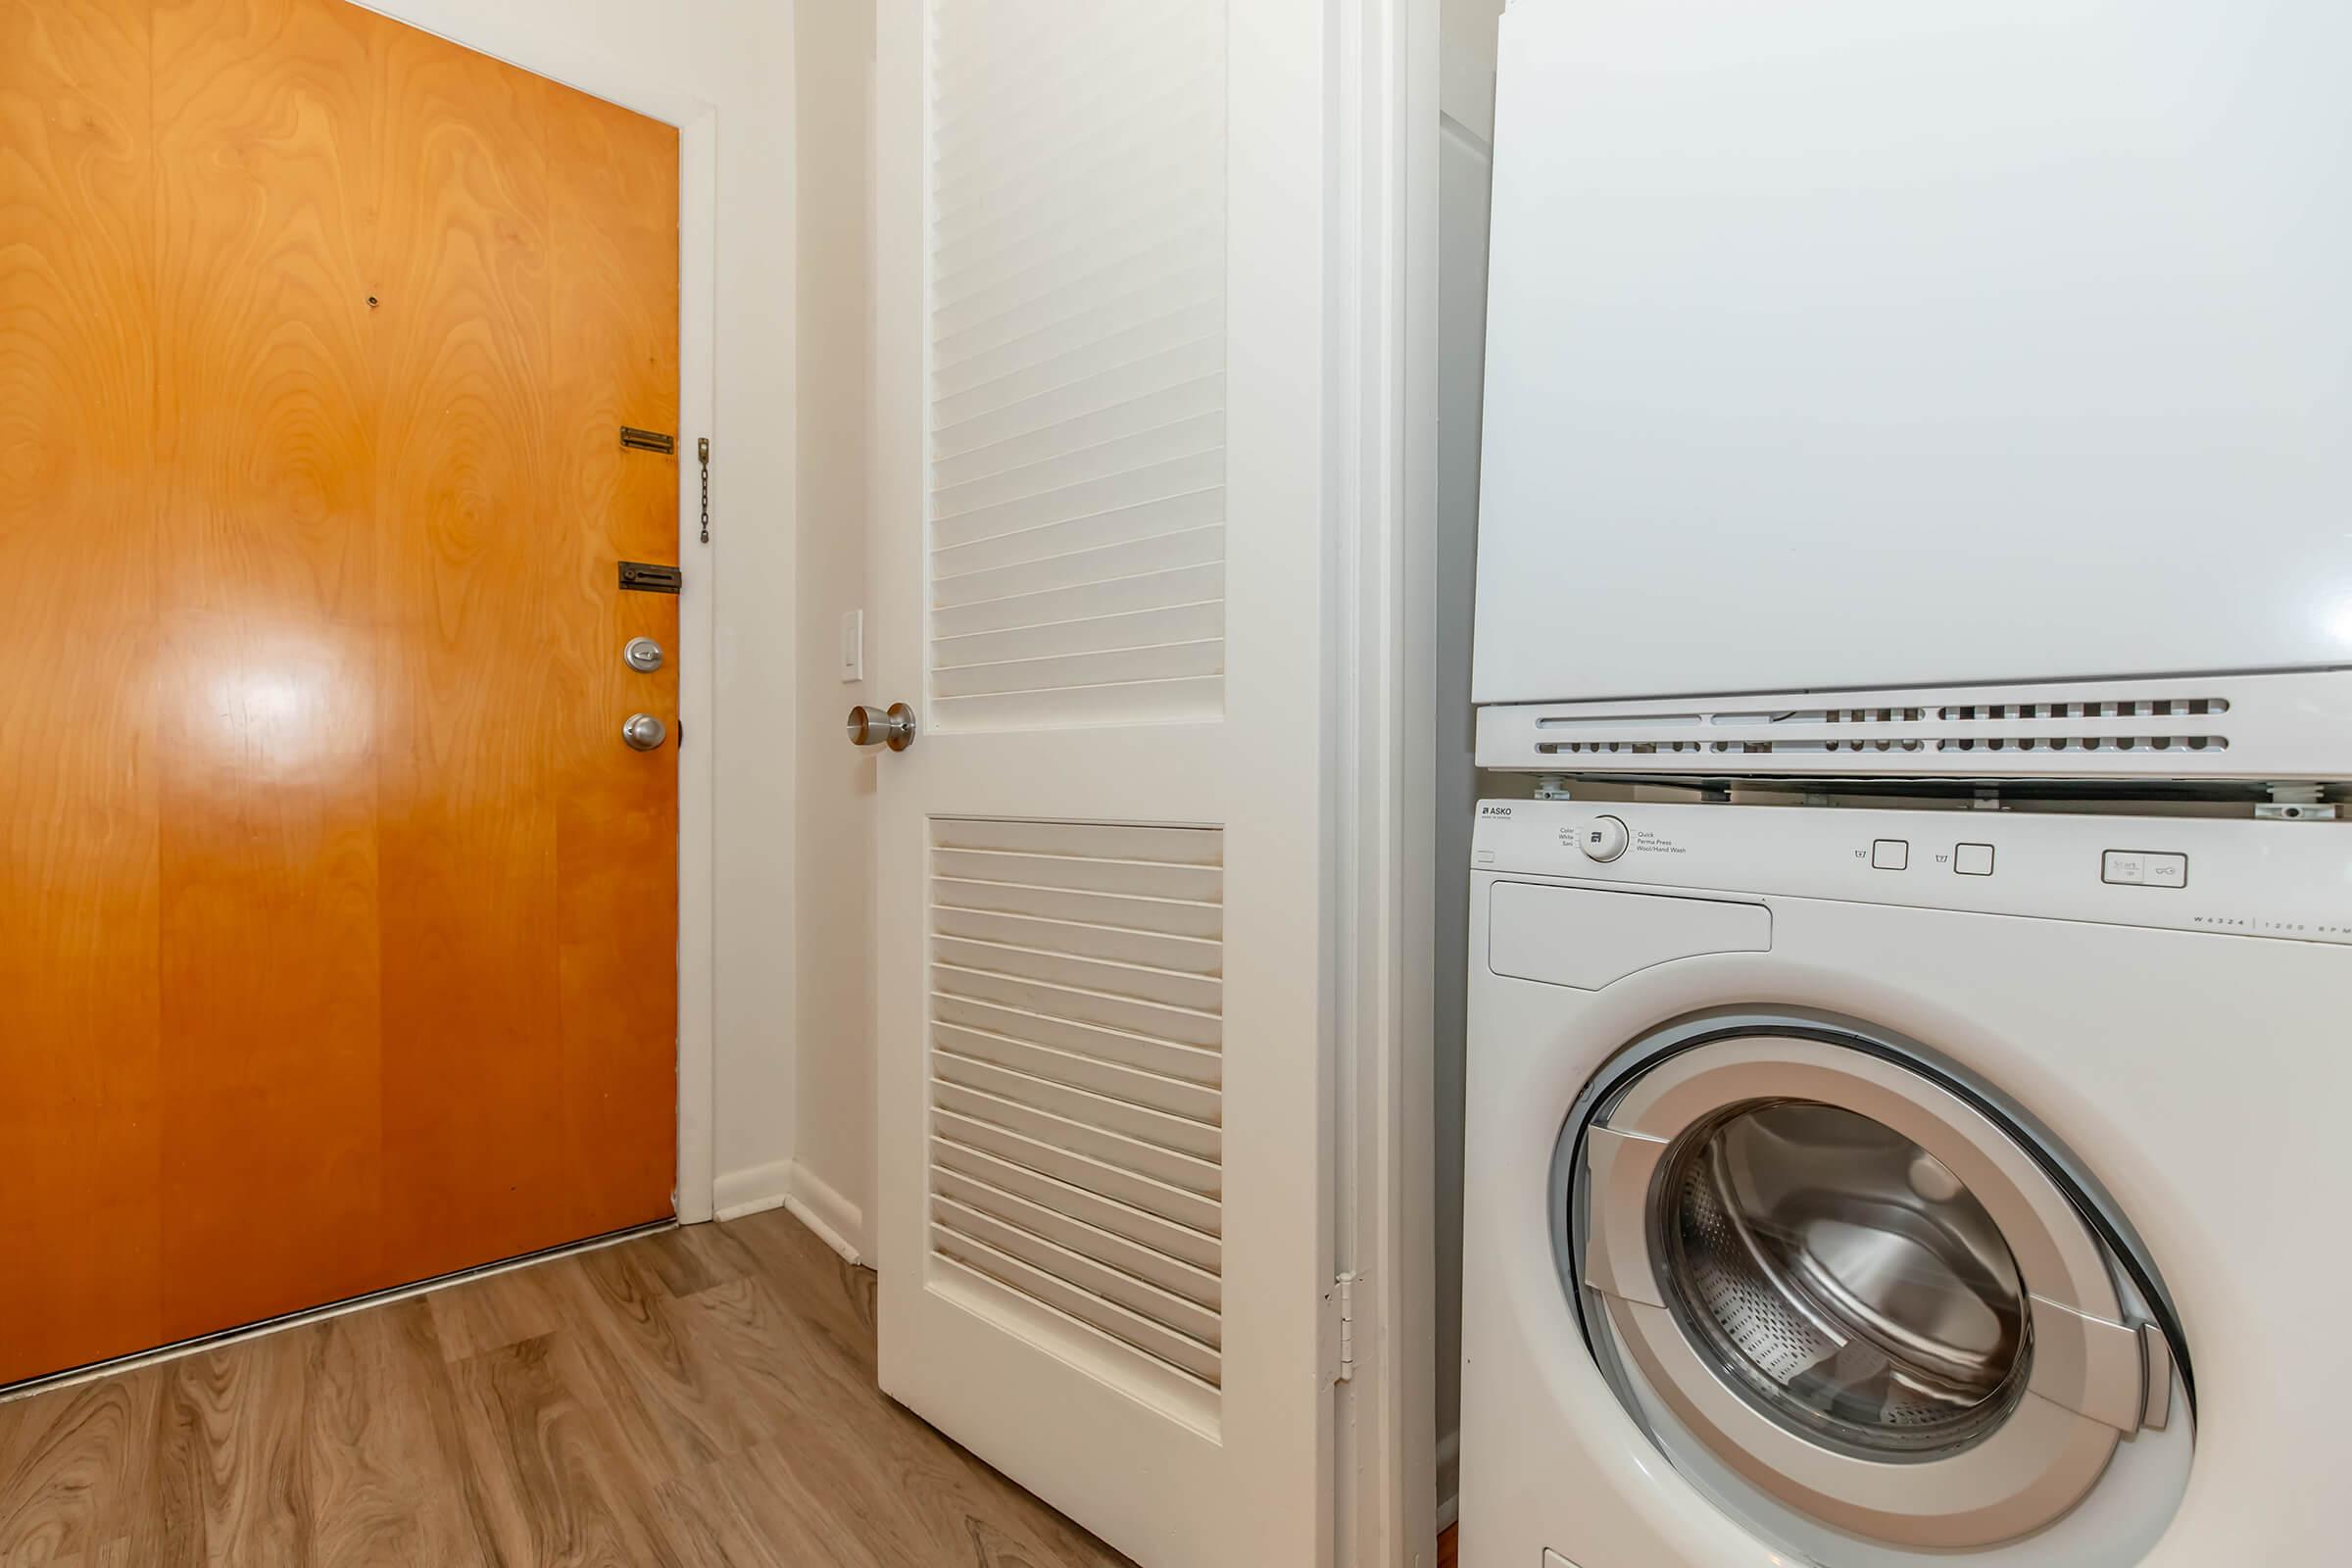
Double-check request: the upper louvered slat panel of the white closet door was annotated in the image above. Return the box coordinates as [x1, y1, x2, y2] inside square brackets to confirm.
[927, 0, 1225, 731]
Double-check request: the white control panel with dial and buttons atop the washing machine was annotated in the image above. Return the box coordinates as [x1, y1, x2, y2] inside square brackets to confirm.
[1472, 800, 2352, 943]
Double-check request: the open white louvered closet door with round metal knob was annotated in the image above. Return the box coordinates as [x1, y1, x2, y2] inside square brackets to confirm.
[872, 0, 1336, 1568]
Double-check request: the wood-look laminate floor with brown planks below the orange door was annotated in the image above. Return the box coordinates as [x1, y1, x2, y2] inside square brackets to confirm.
[0, 1210, 1127, 1568]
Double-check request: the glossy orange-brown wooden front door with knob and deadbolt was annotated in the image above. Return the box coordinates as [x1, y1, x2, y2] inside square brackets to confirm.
[0, 0, 677, 1382]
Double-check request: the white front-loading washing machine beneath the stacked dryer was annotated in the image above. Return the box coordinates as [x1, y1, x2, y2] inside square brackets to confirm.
[1460, 802, 2352, 1568]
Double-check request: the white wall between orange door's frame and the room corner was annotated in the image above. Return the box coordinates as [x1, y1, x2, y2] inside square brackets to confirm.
[353, 0, 804, 1206]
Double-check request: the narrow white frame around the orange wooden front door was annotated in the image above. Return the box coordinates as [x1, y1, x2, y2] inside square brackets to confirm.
[358, 0, 724, 1225]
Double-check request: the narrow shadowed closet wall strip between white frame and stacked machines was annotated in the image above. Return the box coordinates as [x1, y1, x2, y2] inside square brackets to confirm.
[1433, 0, 1503, 1519]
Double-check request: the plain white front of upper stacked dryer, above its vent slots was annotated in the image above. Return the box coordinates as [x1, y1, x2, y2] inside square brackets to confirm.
[1472, 0, 2352, 700]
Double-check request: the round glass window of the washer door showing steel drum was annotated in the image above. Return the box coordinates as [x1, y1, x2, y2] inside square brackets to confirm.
[1656, 1101, 2033, 1460]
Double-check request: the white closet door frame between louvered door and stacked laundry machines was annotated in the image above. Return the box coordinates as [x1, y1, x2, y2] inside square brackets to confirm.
[1334, 0, 1440, 1568]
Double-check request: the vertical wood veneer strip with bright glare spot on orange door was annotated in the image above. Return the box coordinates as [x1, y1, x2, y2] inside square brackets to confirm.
[155, 0, 383, 1340]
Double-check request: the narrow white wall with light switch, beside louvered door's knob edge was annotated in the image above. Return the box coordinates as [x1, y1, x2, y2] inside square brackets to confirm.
[788, 0, 879, 1257]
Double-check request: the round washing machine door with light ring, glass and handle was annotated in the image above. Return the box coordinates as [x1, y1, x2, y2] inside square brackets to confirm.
[1576, 1032, 2174, 1549]
